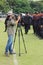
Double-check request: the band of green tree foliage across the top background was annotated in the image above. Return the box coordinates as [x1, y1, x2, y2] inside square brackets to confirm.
[0, 0, 43, 13]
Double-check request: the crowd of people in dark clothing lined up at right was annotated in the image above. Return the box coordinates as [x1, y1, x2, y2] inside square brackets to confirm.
[22, 12, 43, 38]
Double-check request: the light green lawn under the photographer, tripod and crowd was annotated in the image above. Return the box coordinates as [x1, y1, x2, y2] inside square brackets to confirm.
[0, 21, 43, 65]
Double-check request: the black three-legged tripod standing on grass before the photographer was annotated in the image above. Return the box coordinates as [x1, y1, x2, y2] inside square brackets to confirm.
[13, 26, 27, 56]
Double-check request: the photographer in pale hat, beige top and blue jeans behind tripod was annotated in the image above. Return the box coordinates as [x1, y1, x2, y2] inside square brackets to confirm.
[5, 11, 20, 56]
